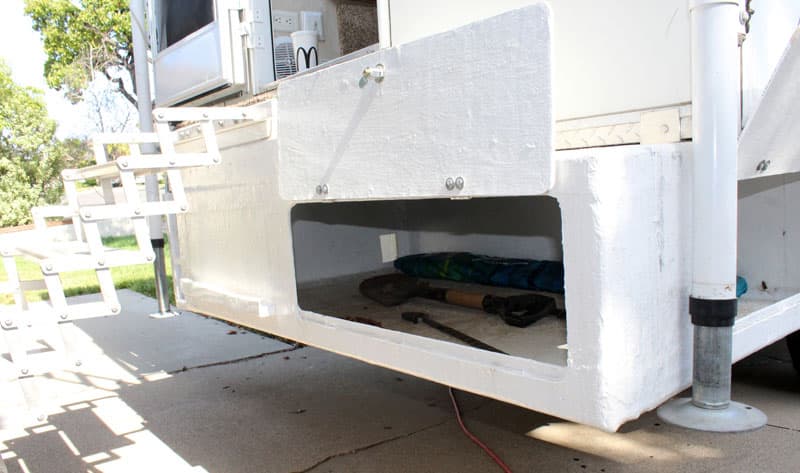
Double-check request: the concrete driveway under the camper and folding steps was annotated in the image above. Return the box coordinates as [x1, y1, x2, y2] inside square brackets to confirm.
[0, 291, 800, 473]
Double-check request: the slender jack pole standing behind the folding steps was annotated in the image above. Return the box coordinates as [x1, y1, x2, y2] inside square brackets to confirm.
[130, 0, 171, 316]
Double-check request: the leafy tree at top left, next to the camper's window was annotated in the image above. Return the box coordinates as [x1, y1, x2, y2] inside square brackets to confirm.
[25, 0, 136, 105]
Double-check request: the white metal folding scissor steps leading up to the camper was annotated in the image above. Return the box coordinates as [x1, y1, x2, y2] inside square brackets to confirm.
[0, 107, 272, 420]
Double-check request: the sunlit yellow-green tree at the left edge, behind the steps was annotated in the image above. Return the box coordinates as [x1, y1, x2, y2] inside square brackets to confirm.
[0, 59, 66, 226]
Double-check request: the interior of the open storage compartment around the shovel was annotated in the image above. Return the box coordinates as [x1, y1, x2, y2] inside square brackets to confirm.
[291, 196, 567, 366]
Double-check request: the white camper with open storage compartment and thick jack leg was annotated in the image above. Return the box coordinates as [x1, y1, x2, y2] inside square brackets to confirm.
[6, 0, 800, 431]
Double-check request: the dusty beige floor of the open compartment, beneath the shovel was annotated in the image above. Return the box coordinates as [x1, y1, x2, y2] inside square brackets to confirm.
[298, 273, 567, 366]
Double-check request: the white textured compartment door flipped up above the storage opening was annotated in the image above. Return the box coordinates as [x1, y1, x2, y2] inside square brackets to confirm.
[277, 4, 553, 201]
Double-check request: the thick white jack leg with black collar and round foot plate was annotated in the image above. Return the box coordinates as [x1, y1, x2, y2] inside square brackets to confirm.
[659, 0, 766, 432]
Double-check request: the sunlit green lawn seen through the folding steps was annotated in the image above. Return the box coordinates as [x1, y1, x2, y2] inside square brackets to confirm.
[0, 236, 175, 304]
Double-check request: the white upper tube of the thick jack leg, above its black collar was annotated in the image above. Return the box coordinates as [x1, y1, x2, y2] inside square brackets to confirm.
[690, 0, 739, 300]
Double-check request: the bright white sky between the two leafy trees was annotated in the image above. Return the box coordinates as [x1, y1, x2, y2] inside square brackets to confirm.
[0, 0, 133, 138]
